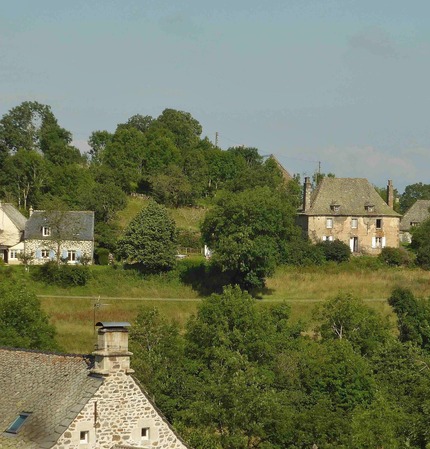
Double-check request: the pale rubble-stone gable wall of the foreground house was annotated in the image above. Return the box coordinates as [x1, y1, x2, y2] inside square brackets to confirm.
[54, 371, 186, 449]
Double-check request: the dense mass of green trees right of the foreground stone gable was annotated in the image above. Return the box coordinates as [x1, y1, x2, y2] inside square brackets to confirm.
[131, 287, 430, 449]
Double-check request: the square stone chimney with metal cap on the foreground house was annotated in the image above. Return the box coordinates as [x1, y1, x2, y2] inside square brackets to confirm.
[91, 322, 134, 376]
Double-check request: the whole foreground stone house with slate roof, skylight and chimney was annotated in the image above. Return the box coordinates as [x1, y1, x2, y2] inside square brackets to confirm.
[0, 323, 190, 449]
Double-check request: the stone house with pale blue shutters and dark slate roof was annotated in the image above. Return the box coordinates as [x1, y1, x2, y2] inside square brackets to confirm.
[24, 210, 94, 264]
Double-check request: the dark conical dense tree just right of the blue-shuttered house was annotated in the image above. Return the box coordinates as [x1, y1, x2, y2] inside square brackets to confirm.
[117, 201, 177, 272]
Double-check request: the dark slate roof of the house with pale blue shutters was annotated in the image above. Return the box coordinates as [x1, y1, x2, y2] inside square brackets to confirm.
[24, 210, 94, 241]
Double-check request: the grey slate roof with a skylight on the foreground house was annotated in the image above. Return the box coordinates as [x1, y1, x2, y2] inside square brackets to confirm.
[0, 348, 103, 449]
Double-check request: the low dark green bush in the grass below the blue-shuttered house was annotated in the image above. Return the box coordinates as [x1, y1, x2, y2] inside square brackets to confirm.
[31, 261, 91, 287]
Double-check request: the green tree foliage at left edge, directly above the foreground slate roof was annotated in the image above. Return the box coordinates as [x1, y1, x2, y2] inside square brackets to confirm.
[0, 279, 58, 350]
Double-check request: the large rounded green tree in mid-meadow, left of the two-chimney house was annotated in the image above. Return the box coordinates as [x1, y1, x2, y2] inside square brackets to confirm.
[201, 187, 299, 289]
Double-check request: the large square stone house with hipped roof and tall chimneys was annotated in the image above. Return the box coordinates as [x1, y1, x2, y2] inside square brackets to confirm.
[297, 177, 400, 254]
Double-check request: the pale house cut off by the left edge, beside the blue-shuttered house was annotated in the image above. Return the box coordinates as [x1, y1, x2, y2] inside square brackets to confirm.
[0, 202, 27, 264]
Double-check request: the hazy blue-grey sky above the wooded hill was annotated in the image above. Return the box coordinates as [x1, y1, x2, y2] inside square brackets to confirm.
[0, 0, 430, 191]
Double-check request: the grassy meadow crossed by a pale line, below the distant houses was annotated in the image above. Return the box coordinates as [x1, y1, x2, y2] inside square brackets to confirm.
[22, 265, 430, 352]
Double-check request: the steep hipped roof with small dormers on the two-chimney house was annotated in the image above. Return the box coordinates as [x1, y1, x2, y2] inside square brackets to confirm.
[300, 177, 400, 217]
